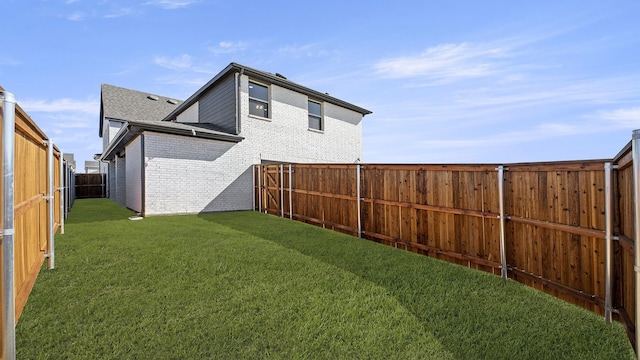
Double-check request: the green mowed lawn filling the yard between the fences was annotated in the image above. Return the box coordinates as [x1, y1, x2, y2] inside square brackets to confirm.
[16, 199, 634, 359]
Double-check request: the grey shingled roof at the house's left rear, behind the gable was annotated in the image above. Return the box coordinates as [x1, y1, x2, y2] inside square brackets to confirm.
[99, 84, 182, 137]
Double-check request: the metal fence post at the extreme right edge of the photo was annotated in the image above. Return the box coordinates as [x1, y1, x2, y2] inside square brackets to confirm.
[631, 130, 640, 359]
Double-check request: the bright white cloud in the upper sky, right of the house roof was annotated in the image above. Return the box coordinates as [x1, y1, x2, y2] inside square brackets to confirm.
[373, 42, 508, 83]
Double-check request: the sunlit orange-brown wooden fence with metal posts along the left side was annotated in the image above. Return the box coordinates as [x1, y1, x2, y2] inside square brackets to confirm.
[0, 87, 72, 359]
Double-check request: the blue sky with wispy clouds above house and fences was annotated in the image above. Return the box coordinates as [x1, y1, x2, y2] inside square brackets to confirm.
[0, 0, 640, 170]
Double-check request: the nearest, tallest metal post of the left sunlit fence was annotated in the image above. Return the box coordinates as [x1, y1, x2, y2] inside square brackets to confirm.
[2, 91, 16, 360]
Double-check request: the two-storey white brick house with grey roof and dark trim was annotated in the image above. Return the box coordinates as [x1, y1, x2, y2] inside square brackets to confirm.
[100, 63, 371, 215]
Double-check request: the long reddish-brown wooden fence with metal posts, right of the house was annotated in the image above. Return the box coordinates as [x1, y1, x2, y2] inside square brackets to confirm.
[254, 136, 636, 352]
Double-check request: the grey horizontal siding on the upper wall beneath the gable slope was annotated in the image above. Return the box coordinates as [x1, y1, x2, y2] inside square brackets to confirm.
[198, 74, 237, 134]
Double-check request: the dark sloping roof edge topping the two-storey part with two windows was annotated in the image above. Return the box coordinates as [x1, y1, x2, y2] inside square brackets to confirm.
[163, 62, 371, 121]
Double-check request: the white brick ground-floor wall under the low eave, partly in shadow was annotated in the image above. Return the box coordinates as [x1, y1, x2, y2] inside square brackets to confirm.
[144, 132, 242, 215]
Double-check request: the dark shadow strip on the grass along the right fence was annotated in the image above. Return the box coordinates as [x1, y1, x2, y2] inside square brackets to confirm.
[199, 212, 633, 359]
